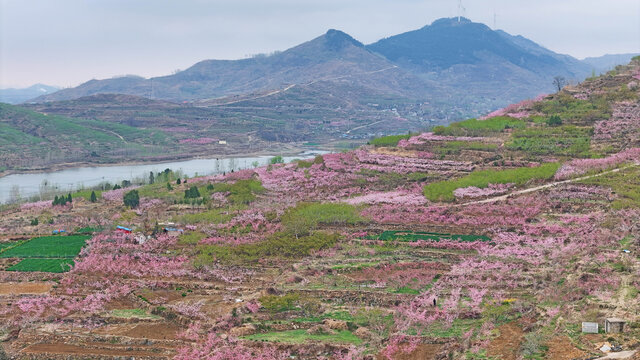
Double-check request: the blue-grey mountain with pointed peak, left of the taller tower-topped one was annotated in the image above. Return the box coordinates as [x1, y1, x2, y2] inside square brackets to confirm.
[36, 30, 428, 102]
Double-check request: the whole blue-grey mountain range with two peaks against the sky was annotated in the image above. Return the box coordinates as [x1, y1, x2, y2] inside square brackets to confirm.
[27, 19, 592, 126]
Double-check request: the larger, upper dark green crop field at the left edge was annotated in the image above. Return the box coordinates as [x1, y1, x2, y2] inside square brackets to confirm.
[0, 235, 89, 258]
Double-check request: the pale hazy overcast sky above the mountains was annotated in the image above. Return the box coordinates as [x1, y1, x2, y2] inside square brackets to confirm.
[0, 0, 640, 88]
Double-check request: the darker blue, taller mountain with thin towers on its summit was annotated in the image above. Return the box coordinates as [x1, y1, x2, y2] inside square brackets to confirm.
[367, 18, 591, 97]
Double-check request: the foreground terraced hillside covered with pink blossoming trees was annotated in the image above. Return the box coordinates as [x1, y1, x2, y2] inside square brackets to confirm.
[0, 58, 640, 360]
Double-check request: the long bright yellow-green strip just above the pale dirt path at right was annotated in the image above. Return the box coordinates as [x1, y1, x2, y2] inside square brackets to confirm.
[423, 163, 560, 201]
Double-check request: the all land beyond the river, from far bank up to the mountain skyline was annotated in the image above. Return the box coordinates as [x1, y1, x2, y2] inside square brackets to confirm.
[0, 18, 630, 173]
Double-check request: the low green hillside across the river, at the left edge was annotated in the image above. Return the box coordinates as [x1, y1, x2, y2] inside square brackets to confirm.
[0, 103, 178, 170]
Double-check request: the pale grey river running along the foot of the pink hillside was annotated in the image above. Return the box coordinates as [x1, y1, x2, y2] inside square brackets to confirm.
[0, 151, 328, 203]
